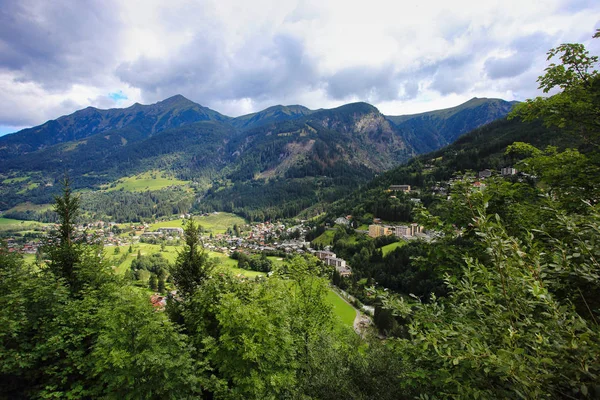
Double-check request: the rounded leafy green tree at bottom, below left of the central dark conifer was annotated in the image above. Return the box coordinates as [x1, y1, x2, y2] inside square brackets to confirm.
[90, 288, 196, 399]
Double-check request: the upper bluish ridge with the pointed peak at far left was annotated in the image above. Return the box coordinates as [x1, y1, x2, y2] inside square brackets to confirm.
[0, 95, 230, 157]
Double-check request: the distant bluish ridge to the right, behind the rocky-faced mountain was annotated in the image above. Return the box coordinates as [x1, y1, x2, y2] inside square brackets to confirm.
[387, 97, 516, 153]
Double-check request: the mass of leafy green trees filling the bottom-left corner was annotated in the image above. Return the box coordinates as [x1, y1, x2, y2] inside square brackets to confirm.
[0, 244, 195, 399]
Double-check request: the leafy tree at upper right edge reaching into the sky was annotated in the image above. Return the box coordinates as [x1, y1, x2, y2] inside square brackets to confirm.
[509, 30, 600, 148]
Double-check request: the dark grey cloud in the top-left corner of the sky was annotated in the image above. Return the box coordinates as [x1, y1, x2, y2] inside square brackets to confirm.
[0, 0, 122, 91]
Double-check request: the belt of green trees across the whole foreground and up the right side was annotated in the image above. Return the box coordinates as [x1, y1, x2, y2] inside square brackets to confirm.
[0, 32, 600, 399]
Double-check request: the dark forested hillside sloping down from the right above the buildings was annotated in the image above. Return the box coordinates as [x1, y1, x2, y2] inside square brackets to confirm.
[328, 115, 585, 221]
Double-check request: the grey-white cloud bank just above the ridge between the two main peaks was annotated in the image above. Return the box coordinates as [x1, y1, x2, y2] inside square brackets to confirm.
[116, 33, 318, 104]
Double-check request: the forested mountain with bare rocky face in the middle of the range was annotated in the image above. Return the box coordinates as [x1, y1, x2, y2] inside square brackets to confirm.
[199, 103, 414, 220]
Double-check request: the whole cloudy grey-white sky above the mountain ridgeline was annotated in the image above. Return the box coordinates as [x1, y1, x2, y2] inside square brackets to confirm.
[0, 0, 600, 134]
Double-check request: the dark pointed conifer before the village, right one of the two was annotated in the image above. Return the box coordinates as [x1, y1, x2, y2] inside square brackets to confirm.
[171, 219, 215, 299]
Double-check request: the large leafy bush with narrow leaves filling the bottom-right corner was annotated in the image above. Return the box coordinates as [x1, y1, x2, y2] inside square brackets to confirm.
[387, 209, 600, 398]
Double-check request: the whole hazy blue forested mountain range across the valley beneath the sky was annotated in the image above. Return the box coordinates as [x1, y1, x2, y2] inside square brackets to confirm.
[0, 95, 513, 219]
